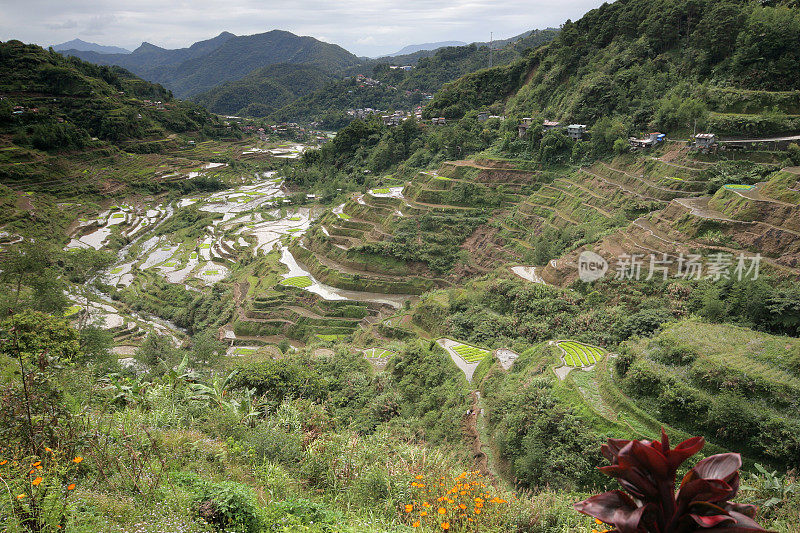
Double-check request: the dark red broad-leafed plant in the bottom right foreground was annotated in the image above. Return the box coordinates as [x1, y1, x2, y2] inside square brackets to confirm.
[574, 429, 776, 533]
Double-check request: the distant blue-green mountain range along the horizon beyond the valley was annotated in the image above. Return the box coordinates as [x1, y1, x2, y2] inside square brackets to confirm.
[59, 30, 558, 120]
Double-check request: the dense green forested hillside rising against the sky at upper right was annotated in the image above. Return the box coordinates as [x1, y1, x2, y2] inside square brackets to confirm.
[429, 0, 800, 129]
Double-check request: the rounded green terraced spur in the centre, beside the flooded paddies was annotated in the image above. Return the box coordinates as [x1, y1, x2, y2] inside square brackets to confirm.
[291, 160, 552, 294]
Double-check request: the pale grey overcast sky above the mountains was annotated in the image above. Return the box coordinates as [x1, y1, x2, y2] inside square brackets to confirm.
[0, 0, 602, 56]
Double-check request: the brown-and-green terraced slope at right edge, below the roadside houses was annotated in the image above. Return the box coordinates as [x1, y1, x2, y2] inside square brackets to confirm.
[539, 147, 800, 284]
